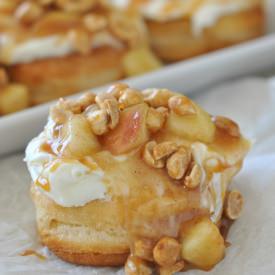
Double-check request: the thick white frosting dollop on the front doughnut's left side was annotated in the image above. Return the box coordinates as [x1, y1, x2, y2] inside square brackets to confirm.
[25, 133, 106, 207]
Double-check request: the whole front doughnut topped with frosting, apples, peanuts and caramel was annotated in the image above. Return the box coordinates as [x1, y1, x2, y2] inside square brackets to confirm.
[25, 83, 250, 274]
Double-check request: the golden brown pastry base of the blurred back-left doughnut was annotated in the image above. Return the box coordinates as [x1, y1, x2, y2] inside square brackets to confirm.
[10, 47, 124, 105]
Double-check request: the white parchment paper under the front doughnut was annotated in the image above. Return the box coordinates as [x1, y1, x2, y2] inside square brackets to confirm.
[0, 79, 275, 275]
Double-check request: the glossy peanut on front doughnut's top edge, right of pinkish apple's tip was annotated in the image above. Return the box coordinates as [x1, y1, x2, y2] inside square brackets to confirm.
[142, 89, 173, 107]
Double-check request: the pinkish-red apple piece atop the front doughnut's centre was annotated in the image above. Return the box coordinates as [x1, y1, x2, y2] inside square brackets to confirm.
[103, 103, 149, 155]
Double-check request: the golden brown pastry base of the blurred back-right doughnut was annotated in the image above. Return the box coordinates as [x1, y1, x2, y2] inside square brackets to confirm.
[148, 6, 265, 62]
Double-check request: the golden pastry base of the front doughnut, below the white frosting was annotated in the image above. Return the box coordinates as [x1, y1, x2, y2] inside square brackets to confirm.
[31, 186, 129, 266]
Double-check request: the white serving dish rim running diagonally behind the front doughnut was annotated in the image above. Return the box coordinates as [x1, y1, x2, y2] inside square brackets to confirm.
[0, 0, 275, 155]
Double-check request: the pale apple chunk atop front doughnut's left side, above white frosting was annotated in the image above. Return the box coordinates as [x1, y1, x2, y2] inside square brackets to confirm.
[61, 115, 100, 158]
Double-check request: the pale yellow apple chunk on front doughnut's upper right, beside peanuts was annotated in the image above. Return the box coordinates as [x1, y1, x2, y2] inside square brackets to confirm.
[166, 103, 215, 143]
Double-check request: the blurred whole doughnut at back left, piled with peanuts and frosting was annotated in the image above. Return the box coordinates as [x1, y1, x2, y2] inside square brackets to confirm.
[0, 0, 161, 110]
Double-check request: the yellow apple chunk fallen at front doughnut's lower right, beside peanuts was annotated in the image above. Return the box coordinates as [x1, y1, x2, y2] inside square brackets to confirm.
[181, 217, 225, 270]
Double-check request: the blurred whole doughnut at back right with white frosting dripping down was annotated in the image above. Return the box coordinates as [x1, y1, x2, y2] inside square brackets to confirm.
[109, 0, 265, 62]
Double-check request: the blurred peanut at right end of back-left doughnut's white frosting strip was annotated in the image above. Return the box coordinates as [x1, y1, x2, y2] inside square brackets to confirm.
[68, 29, 91, 54]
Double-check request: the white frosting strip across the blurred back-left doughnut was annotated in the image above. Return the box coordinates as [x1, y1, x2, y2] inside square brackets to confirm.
[0, 31, 123, 64]
